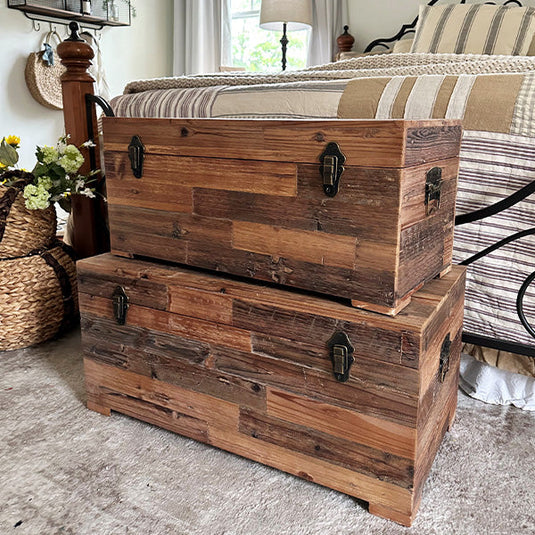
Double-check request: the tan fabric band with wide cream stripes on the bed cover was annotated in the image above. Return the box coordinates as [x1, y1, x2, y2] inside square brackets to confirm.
[338, 73, 535, 137]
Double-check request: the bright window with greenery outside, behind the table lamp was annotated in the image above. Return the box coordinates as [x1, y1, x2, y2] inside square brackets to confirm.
[231, 0, 309, 72]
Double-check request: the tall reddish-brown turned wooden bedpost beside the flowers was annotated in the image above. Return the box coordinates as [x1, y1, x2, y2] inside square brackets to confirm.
[58, 22, 109, 258]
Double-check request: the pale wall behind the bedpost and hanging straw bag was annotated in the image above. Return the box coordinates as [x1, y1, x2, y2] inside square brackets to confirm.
[0, 0, 173, 167]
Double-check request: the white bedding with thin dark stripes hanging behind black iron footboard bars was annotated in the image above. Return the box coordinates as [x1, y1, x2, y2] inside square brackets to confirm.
[453, 131, 535, 345]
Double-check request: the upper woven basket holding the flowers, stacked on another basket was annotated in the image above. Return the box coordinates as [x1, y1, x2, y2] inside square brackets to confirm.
[0, 171, 56, 259]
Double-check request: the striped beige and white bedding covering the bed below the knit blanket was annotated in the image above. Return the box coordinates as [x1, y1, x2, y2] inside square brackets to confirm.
[112, 55, 535, 356]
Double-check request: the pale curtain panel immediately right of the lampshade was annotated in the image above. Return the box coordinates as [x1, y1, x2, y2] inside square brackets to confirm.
[307, 0, 349, 65]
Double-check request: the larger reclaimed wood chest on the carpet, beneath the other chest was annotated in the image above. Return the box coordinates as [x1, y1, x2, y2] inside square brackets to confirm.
[78, 255, 465, 525]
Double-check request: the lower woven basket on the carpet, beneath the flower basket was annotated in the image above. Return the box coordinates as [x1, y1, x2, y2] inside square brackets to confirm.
[0, 245, 78, 351]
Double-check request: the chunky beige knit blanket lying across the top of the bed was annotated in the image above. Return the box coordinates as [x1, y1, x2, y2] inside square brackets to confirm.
[124, 53, 535, 94]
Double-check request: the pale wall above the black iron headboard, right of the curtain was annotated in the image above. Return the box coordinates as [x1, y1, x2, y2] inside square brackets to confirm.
[348, 0, 535, 52]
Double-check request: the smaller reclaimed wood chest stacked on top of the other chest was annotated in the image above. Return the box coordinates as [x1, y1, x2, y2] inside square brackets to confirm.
[104, 118, 461, 314]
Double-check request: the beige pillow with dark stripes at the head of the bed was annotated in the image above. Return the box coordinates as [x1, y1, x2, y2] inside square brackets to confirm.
[411, 4, 535, 56]
